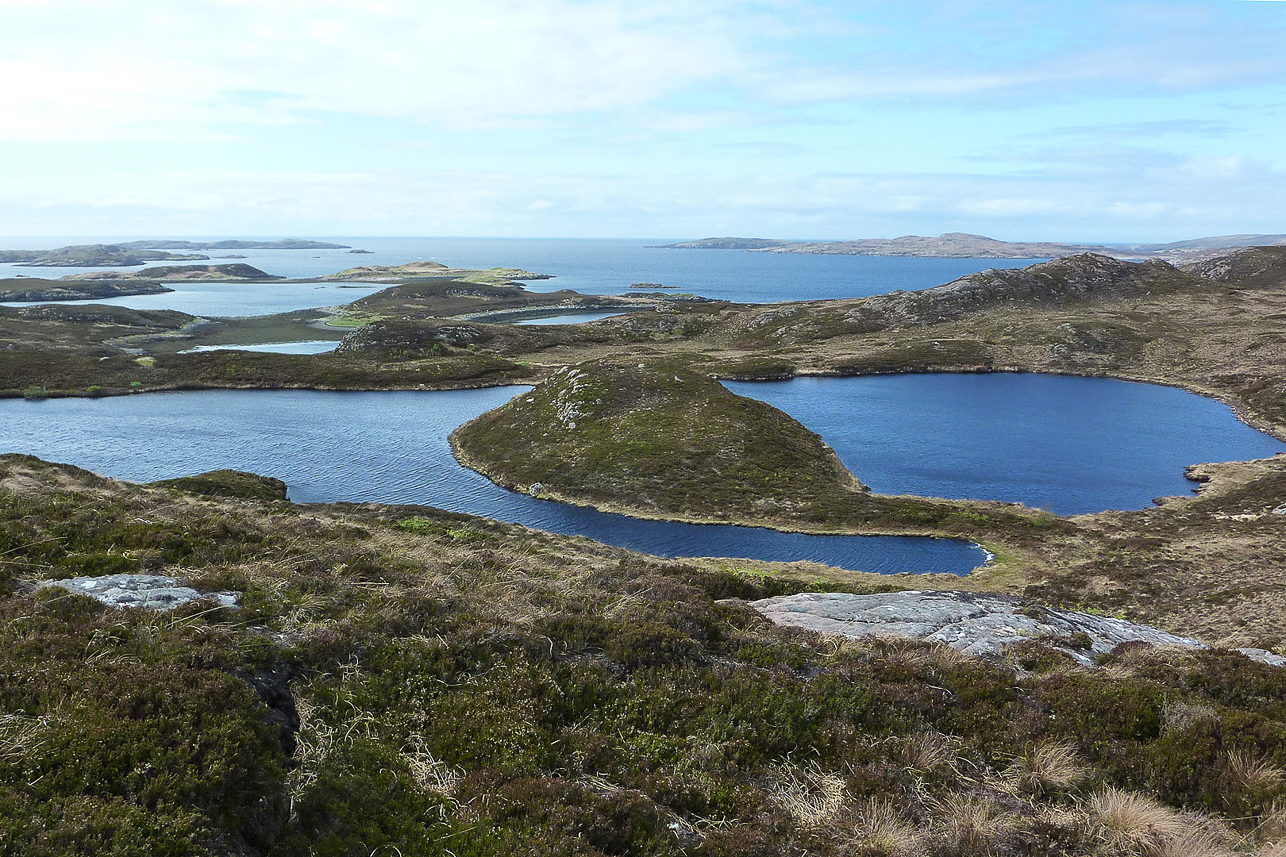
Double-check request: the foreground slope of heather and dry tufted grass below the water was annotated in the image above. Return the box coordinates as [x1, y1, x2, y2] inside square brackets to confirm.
[0, 456, 1286, 857]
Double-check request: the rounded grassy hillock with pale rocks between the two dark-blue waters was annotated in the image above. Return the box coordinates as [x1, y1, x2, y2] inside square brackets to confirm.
[453, 360, 862, 521]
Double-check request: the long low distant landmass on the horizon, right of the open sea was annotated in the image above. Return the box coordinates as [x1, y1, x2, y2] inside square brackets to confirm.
[661, 232, 1286, 261]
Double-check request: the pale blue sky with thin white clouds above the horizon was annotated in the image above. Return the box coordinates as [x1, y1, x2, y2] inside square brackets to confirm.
[0, 0, 1286, 243]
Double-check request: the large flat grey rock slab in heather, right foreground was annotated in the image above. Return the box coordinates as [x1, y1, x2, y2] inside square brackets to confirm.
[750, 591, 1286, 665]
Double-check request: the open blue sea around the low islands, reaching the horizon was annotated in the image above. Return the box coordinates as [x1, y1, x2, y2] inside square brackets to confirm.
[0, 237, 1040, 307]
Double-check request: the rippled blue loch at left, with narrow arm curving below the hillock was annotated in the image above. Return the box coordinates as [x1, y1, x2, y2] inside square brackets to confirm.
[0, 387, 985, 574]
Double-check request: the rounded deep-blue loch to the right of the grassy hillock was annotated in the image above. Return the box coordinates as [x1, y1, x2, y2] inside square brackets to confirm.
[725, 374, 1286, 506]
